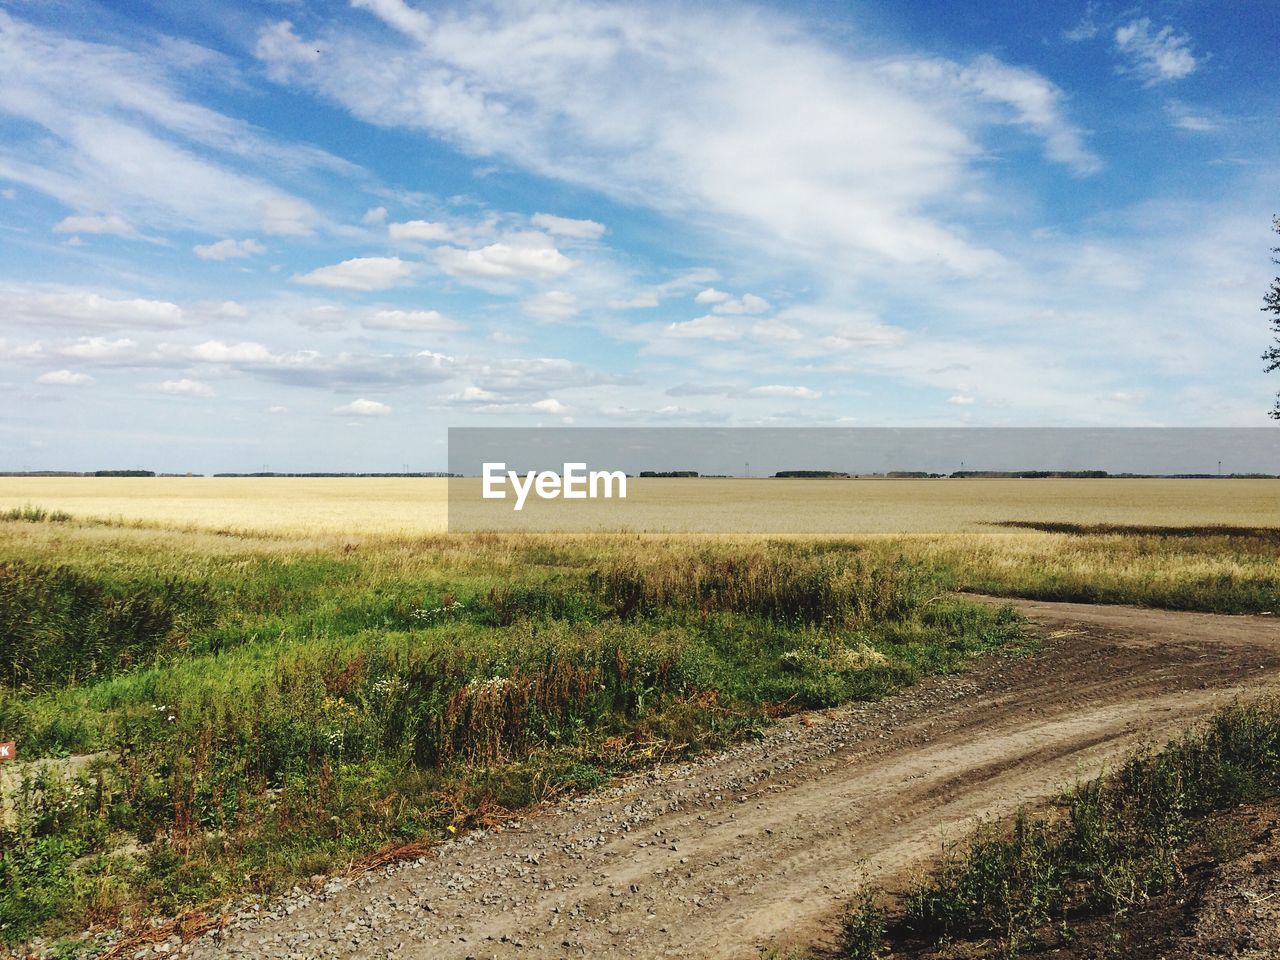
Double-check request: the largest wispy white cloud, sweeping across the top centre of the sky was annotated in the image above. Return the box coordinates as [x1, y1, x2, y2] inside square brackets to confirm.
[264, 6, 1098, 276]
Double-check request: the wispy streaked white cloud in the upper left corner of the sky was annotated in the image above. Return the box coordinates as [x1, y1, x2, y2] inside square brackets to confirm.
[0, 10, 335, 236]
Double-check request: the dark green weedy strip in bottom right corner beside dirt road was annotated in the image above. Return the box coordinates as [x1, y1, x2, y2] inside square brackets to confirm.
[844, 700, 1280, 960]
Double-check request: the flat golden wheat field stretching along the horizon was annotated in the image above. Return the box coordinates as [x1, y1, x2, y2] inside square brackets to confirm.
[0, 477, 1280, 536]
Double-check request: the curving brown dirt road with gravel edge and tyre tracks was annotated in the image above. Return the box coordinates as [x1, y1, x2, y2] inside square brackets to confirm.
[195, 600, 1280, 960]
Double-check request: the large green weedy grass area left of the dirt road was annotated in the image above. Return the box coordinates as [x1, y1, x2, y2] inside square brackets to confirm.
[0, 517, 1016, 943]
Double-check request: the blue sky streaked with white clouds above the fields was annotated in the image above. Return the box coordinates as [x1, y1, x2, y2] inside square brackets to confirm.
[0, 0, 1280, 472]
